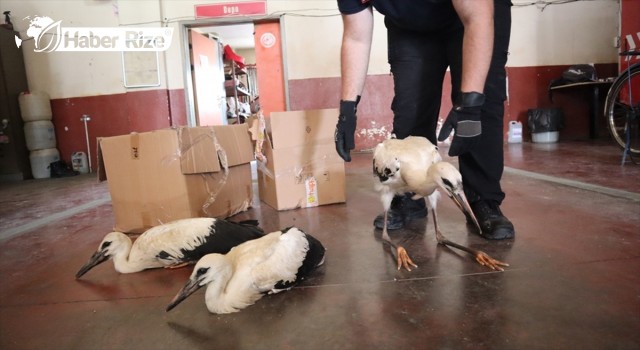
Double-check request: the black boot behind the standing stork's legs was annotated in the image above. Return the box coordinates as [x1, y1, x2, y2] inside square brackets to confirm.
[373, 193, 427, 230]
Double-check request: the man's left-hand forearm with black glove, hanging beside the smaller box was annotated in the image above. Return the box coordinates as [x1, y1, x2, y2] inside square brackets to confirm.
[335, 7, 373, 162]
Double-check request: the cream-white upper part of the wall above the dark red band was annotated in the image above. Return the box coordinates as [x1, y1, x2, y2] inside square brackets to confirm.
[0, 0, 619, 98]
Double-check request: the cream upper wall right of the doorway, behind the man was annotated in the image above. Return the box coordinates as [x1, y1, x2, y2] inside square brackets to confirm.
[285, 0, 620, 79]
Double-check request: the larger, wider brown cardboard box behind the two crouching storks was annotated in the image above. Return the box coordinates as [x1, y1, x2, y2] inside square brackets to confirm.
[98, 125, 253, 232]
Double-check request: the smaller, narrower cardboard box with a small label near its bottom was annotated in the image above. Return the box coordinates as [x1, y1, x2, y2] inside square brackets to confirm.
[258, 109, 346, 210]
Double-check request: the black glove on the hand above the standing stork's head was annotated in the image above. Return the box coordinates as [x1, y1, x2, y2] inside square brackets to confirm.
[438, 92, 484, 157]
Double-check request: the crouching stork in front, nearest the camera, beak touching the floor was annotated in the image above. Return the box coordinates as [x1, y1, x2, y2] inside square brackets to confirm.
[167, 227, 325, 314]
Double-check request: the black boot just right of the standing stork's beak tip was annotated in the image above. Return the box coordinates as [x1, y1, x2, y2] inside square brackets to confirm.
[467, 200, 515, 240]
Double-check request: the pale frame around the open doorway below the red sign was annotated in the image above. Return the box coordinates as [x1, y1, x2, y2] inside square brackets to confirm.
[179, 15, 290, 126]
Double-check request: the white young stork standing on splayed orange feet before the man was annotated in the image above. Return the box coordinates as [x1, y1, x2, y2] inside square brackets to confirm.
[373, 136, 509, 271]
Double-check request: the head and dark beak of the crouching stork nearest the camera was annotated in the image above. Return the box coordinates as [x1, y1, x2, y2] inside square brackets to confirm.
[166, 254, 231, 312]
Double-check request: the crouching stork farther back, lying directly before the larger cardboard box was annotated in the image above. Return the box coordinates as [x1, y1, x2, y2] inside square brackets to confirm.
[76, 218, 264, 278]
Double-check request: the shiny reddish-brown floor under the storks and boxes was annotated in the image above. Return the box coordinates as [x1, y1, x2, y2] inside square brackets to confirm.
[0, 142, 640, 350]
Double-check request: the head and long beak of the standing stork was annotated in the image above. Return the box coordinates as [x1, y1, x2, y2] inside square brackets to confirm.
[427, 162, 482, 232]
